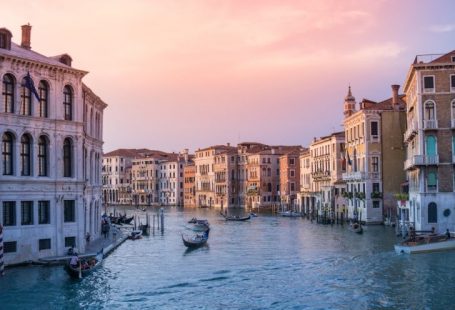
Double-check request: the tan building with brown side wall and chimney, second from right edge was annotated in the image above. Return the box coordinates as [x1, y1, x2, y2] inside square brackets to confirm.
[343, 85, 406, 224]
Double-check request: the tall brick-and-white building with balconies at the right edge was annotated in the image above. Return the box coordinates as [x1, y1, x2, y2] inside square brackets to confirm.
[401, 51, 455, 232]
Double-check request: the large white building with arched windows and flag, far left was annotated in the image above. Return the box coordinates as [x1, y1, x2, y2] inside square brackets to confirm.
[0, 25, 107, 264]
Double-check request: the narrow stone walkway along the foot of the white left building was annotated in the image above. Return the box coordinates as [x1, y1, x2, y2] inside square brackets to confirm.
[35, 225, 131, 265]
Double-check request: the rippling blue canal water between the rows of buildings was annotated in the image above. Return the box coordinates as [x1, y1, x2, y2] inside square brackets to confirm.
[0, 208, 455, 309]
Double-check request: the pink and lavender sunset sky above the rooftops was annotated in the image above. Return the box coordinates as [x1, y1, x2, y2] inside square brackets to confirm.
[0, 0, 455, 152]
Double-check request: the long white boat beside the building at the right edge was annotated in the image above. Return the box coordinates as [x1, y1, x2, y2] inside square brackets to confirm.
[395, 234, 455, 254]
